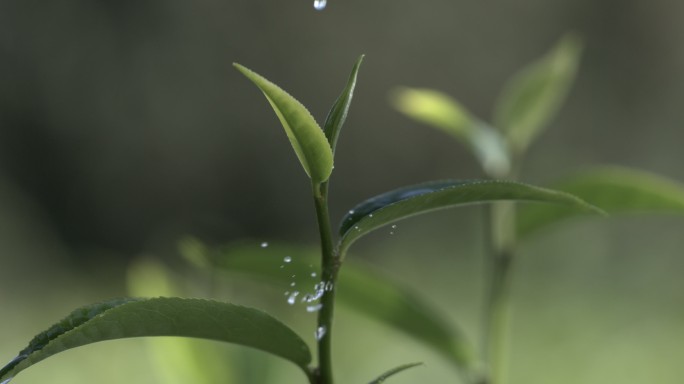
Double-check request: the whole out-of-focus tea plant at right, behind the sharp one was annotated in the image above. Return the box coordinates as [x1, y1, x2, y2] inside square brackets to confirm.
[391, 34, 684, 384]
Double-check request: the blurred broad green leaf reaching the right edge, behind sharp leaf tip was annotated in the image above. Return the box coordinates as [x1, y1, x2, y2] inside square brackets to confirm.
[517, 166, 684, 238]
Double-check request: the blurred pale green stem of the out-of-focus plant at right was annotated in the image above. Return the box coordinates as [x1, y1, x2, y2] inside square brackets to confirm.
[483, 198, 515, 384]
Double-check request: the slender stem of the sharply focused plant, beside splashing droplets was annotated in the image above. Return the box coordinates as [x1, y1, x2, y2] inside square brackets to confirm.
[313, 182, 340, 384]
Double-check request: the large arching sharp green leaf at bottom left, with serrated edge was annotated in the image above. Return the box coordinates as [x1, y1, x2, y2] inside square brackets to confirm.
[0, 298, 311, 383]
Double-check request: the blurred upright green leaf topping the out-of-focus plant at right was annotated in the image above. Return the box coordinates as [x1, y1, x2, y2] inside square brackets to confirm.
[494, 34, 581, 153]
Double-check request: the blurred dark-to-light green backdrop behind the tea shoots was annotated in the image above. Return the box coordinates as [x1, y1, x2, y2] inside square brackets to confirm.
[0, 0, 684, 384]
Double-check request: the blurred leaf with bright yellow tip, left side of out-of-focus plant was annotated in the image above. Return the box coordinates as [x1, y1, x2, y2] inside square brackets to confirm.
[391, 88, 510, 176]
